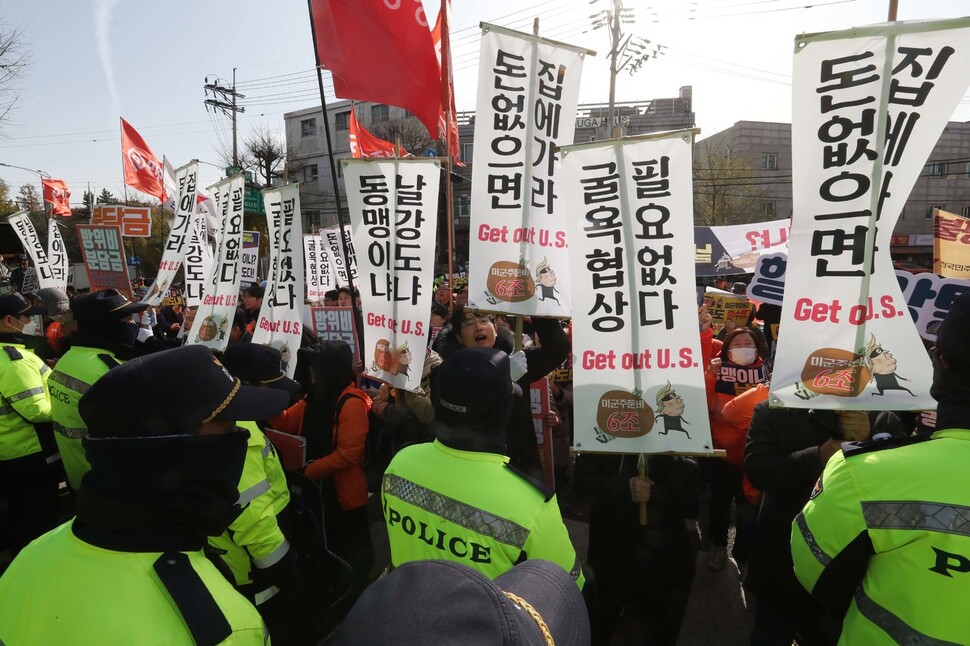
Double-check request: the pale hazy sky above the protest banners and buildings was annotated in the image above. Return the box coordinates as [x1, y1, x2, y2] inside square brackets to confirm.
[0, 0, 970, 206]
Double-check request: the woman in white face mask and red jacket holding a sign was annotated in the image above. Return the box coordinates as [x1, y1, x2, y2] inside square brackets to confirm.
[702, 327, 769, 570]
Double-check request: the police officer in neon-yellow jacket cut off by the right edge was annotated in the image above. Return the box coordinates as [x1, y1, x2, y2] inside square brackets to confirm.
[791, 294, 970, 645]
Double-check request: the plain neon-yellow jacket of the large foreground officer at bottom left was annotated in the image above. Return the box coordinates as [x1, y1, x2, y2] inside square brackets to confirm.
[0, 521, 269, 646]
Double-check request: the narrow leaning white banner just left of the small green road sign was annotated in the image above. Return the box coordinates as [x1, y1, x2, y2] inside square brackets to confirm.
[188, 175, 246, 352]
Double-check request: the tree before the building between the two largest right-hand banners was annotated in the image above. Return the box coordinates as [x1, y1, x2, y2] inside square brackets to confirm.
[694, 141, 764, 226]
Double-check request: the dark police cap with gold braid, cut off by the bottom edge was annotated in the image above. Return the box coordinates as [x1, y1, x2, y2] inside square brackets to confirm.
[324, 560, 589, 646]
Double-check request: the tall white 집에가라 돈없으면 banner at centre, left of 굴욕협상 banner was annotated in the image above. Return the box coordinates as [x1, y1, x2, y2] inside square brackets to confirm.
[468, 25, 587, 317]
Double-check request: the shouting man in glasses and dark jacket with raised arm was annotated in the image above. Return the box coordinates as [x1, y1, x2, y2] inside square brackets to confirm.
[432, 306, 569, 478]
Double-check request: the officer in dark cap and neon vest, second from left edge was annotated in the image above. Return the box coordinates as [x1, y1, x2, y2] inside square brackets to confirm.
[49, 289, 148, 491]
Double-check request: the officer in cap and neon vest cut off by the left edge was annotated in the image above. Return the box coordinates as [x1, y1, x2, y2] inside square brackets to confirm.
[0, 294, 60, 554]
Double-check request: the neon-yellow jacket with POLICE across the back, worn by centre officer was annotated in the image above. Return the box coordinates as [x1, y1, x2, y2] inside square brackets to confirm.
[381, 441, 585, 588]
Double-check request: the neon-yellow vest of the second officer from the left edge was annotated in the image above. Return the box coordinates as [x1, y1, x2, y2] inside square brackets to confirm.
[47, 346, 122, 491]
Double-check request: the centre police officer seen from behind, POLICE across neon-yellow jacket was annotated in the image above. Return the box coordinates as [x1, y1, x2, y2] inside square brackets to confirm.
[381, 348, 585, 588]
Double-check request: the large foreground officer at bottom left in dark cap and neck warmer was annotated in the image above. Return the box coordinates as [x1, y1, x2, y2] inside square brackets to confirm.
[0, 346, 288, 645]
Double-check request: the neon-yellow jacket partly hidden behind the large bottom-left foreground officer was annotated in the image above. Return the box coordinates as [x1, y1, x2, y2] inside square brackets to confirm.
[209, 422, 290, 585]
